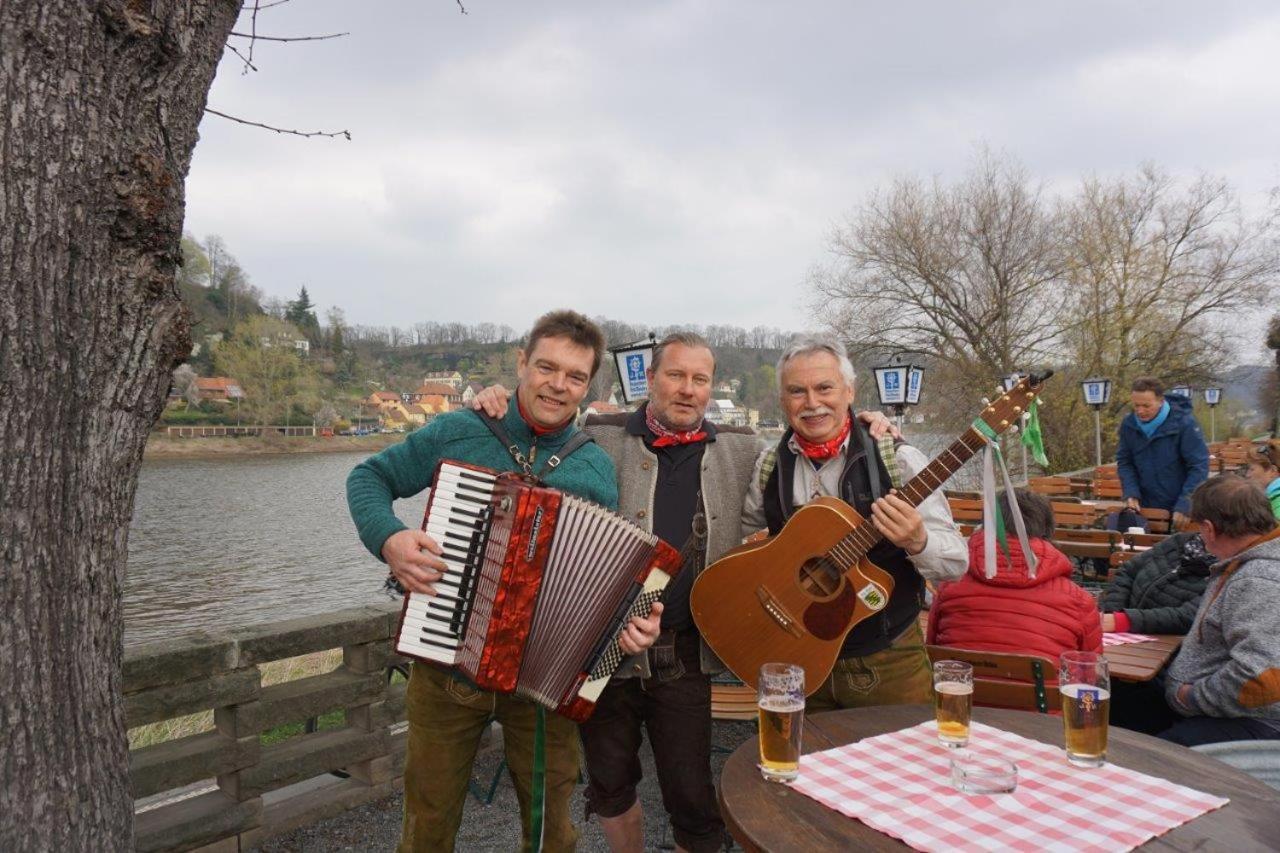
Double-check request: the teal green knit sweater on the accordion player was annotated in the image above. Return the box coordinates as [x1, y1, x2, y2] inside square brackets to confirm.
[347, 401, 618, 560]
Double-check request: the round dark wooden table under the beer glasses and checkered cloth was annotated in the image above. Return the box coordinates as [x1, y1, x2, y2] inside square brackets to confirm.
[719, 704, 1280, 853]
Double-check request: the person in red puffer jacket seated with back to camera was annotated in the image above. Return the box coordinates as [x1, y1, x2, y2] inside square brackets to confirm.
[928, 489, 1102, 662]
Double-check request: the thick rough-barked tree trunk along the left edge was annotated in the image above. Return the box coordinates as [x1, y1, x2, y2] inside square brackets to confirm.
[0, 0, 239, 850]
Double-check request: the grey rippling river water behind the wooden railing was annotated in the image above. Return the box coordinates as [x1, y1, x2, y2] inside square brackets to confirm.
[124, 435, 973, 643]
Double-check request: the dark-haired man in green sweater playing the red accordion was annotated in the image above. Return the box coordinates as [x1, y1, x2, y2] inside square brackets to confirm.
[347, 311, 662, 852]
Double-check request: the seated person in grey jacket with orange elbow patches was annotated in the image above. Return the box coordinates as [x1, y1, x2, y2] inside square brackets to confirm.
[1160, 476, 1280, 747]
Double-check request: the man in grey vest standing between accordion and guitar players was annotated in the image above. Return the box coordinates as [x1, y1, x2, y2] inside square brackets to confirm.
[476, 333, 888, 853]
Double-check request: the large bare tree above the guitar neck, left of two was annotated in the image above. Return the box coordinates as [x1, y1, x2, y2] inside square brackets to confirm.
[810, 152, 1062, 378]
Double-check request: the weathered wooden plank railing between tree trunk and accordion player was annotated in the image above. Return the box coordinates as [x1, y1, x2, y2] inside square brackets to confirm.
[124, 603, 406, 850]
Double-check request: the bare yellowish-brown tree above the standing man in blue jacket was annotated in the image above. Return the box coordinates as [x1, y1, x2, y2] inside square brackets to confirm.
[1064, 165, 1280, 384]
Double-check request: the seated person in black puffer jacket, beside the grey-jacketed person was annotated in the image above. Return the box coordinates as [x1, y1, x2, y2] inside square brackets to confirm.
[1098, 533, 1216, 634]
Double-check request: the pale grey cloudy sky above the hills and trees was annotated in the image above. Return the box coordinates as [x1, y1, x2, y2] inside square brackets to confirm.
[187, 0, 1280, 353]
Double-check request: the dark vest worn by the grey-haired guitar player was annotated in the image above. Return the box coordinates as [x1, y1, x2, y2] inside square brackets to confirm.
[764, 418, 924, 658]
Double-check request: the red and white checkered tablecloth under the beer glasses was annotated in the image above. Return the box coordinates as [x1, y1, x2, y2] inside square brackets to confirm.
[791, 721, 1228, 853]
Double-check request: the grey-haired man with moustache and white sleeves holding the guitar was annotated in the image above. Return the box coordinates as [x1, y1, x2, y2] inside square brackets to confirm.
[742, 338, 968, 712]
